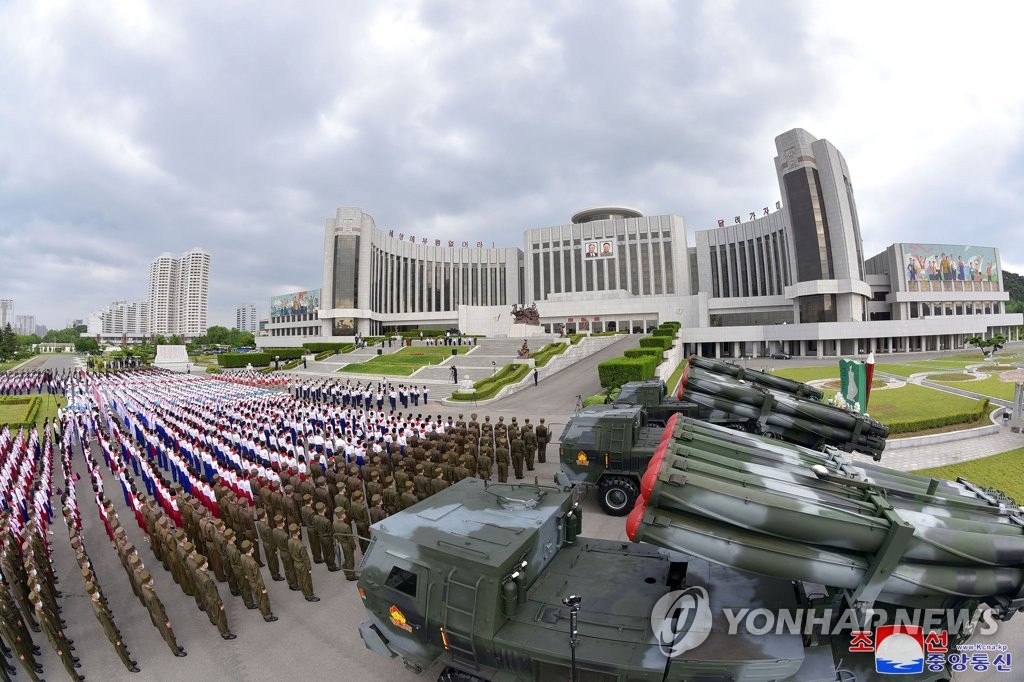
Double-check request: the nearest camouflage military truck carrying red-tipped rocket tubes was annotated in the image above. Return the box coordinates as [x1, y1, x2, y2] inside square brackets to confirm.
[357, 409, 1024, 682]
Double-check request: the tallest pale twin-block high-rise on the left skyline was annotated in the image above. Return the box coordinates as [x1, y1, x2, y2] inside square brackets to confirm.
[148, 247, 210, 338]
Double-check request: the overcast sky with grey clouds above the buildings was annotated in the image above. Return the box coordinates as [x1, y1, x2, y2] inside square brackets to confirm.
[0, 0, 1024, 328]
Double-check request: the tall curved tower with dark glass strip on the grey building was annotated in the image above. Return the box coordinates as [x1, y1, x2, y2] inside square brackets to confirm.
[775, 128, 871, 323]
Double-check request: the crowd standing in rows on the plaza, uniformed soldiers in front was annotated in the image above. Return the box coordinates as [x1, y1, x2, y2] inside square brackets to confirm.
[0, 370, 551, 680]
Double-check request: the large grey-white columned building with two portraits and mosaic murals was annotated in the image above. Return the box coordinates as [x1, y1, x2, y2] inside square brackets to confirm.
[260, 129, 1024, 357]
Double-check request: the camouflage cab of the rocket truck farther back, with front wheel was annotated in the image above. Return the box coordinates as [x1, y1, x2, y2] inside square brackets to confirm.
[558, 404, 666, 516]
